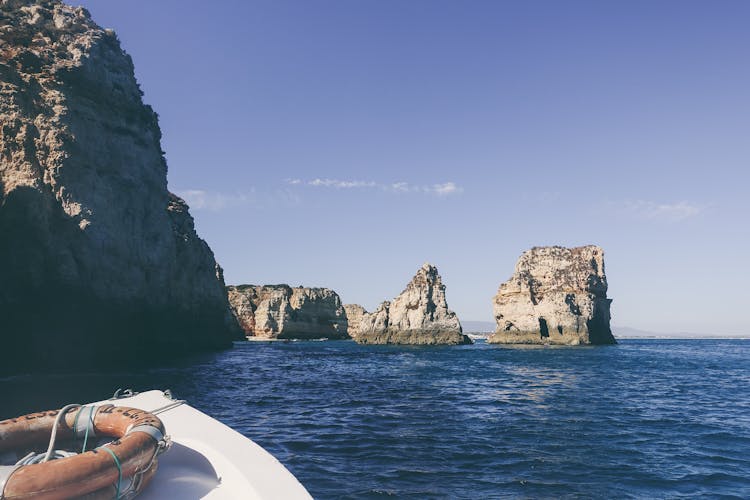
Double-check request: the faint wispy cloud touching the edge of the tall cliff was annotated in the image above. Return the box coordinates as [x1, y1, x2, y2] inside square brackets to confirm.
[175, 188, 300, 212]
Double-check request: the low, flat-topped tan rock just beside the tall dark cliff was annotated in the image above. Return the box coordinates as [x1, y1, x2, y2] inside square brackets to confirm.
[227, 285, 348, 339]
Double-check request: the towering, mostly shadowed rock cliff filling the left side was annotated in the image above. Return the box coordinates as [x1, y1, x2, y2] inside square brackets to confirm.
[0, 0, 239, 370]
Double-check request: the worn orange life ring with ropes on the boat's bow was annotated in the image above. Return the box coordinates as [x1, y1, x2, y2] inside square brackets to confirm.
[0, 404, 168, 500]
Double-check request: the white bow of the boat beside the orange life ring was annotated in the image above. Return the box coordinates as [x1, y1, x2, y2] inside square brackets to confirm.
[99, 391, 312, 500]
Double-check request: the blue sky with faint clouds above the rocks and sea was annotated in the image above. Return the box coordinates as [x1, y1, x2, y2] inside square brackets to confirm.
[82, 0, 750, 333]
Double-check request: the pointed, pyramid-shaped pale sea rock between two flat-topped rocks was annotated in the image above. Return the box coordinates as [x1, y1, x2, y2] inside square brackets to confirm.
[355, 264, 472, 345]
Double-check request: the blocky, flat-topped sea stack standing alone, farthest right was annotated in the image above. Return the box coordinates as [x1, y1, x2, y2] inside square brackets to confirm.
[488, 245, 615, 345]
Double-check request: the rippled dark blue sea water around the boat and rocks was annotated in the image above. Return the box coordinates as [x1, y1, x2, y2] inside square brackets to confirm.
[0, 340, 750, 499]
